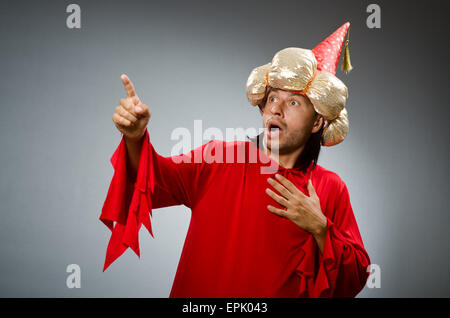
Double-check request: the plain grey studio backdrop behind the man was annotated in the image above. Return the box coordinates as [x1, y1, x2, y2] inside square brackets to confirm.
[0, 0, 450, 297]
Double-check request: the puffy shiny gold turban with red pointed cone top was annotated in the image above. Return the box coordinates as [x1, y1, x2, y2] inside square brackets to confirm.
[246, 22, 350, 146]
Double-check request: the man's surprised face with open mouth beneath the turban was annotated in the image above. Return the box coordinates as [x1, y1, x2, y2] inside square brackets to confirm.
[260, 88, 323, 154]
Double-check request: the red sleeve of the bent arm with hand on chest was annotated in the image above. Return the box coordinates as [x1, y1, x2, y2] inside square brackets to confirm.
[297, 182, 370, 297]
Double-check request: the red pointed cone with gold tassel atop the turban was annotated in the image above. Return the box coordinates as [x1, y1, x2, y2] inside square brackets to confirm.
[312, 22, 352, 75]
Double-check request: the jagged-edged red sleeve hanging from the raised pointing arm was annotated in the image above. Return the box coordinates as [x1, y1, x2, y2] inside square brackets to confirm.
[100, 130, 209, 271]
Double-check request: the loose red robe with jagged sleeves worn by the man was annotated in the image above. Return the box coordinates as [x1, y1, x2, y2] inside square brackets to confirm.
[100, 131, 370, 298]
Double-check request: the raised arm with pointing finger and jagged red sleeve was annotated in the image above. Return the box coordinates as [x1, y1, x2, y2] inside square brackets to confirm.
[100, 75, 213, 270]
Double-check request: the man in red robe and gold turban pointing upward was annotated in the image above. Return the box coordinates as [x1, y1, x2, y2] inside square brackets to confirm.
[100, 23, 370, 297]
